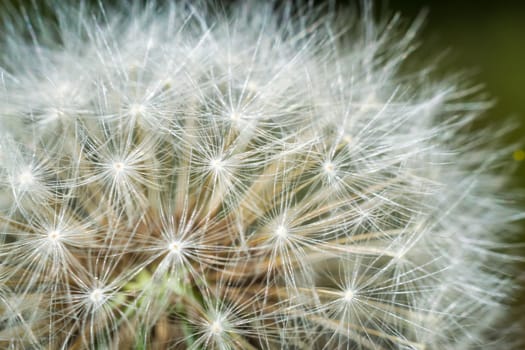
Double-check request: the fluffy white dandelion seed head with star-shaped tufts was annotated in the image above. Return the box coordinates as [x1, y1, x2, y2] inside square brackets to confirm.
[0, 1, 515, 350]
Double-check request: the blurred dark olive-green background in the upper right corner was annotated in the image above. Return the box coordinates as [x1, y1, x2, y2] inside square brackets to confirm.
[386, 0, 525, 180]
